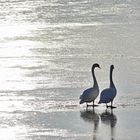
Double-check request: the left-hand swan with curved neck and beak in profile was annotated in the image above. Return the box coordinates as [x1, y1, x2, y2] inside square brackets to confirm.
[80, 63, 100, 107]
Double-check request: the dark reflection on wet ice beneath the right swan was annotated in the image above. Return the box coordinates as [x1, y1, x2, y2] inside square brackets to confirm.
[100, 109, 117, 140]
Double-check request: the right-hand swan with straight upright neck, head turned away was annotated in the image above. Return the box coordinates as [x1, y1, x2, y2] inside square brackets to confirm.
[99, 65, 117, 108]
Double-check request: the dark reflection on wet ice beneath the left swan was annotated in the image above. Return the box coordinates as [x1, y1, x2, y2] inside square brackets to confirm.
[81, 109, 99, 140]
